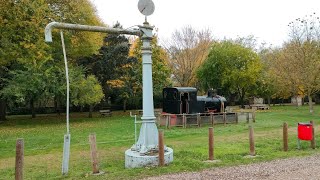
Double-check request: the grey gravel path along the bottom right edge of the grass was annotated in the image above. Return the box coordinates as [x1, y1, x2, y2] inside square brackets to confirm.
[147, 154, 320, 180]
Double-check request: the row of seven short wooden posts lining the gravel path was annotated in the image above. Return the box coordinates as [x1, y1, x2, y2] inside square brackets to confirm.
[15, 121, 316, 180]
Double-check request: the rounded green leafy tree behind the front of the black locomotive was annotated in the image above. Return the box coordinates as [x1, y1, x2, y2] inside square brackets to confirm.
[197, 40, 261, 106]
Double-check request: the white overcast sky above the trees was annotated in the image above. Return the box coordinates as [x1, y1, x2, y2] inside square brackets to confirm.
[91, 0, 320, 46]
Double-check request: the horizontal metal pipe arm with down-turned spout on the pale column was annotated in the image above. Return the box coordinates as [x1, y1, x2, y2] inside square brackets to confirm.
[45, 22, 142, 42]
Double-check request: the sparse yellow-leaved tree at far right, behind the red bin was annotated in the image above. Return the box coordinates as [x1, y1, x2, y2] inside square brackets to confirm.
[284, 13, 320, 113]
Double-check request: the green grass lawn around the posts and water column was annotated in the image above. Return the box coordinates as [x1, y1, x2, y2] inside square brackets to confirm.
[0, 106, 320, 179]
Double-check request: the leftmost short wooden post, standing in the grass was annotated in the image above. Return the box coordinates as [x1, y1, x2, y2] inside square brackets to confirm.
[15, 139, 24, 180]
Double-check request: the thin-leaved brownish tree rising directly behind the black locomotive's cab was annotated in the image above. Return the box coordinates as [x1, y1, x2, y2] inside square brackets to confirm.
[166, 26, 212, 86]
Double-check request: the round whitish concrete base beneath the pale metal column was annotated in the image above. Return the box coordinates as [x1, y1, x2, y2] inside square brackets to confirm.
[125, 147, 173, 168]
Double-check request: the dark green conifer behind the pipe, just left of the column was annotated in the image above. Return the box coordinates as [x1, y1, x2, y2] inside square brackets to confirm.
[78, 23, 132, 109]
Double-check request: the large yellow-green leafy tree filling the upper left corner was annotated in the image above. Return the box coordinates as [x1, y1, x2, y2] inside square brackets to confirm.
[0, 0, 101, 120]
